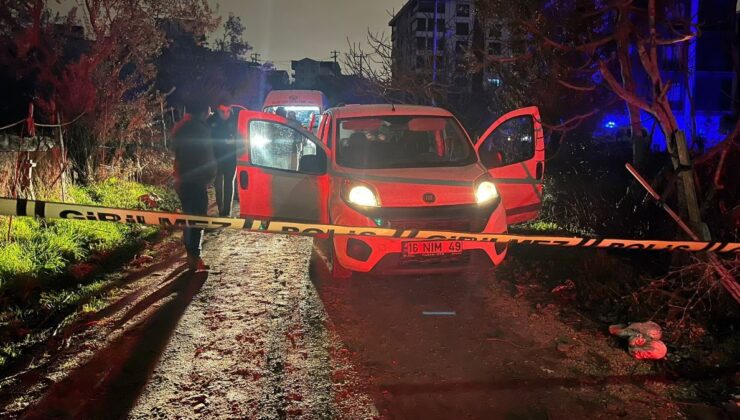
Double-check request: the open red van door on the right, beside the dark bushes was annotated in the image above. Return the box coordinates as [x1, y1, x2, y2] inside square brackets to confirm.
[476, 106, 545, 225]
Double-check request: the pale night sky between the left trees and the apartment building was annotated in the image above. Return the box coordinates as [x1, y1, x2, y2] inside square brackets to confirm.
[49, 0, 406, 70]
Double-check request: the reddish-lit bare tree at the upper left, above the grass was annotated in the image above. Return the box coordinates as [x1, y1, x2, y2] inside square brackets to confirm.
[0, 0, 218, 180]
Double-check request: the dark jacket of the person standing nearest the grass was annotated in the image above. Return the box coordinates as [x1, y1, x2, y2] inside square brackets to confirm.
[173, 116, 216, 186]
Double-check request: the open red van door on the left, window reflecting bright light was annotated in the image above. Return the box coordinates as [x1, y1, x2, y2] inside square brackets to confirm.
[237, 111, 329, 223]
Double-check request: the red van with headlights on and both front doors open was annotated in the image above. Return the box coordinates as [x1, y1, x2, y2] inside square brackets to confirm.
[238, 105, 545, 277]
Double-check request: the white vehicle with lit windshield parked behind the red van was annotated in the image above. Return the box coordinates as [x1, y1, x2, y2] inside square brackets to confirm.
[262, 90, 328, 131]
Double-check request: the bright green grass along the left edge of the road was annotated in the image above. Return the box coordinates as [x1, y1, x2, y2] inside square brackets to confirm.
[0, 178, 178, 368]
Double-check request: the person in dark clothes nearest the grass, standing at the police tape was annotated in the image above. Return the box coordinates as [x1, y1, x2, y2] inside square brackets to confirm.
[173, 103, 216, 271]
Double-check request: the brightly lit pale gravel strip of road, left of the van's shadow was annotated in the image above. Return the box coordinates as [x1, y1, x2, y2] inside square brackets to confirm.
[131, 232, 373, 419]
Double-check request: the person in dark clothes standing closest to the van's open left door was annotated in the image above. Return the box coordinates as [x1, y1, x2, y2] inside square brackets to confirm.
[208, 104, 236, 217]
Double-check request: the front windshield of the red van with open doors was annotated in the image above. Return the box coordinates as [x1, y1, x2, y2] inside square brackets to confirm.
[335, 116, 477, 169]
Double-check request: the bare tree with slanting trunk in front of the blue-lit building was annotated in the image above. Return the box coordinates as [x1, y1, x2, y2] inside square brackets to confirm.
[482, 0, 701, 218]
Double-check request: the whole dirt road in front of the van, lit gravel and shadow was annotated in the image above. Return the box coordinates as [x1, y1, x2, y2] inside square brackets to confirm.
[0, 228, 692, 419]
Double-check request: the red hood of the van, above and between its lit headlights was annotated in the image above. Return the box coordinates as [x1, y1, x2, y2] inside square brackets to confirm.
[334, 163, 487, 207]
